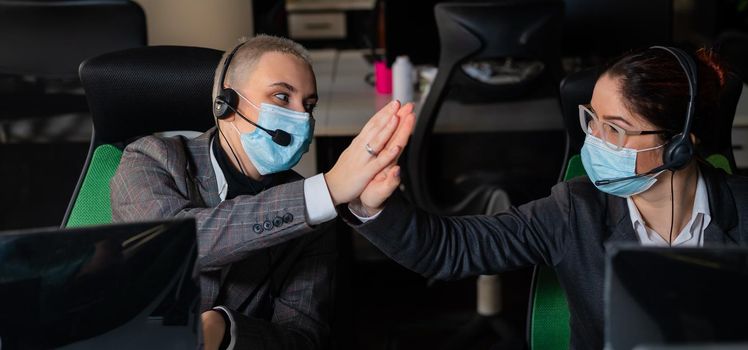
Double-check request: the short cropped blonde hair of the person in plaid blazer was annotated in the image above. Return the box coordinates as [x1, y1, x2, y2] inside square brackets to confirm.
[213, 34, 312, 100]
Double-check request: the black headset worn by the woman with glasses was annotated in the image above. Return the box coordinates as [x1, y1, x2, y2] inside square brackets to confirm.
[595, 46, 698, 186]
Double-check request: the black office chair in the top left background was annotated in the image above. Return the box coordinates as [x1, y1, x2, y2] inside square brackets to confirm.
[0, 0, 146, 141]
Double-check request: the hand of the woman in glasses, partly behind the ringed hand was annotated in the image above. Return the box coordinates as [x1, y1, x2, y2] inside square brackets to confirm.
[351, 103, 416, 216]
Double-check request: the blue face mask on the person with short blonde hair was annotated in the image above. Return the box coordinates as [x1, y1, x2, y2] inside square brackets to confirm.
[231, 95, 314, 175]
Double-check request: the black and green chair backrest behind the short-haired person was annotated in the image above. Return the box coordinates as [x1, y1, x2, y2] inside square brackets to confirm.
[63, 46, 223, 226]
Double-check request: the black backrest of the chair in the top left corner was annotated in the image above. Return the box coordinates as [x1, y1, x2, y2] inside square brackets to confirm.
[0, 0, 146, 79]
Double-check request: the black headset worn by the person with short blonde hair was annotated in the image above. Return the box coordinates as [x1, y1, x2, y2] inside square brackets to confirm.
[213, 43, 293, 146]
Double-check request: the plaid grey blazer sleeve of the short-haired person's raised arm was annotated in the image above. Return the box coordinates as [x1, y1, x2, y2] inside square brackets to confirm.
[110, 136, 315, 271]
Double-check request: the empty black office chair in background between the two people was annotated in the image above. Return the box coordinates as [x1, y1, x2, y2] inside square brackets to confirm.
[405, 1, 563, 215]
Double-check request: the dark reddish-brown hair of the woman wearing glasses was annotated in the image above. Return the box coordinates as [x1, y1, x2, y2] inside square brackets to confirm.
[602, 48, 726, 140]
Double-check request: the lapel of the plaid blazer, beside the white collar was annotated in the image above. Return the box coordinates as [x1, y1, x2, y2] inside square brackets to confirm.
[187, 127, 221, 207]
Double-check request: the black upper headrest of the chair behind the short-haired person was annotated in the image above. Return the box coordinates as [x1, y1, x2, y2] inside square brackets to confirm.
[80, 46, 223, 143]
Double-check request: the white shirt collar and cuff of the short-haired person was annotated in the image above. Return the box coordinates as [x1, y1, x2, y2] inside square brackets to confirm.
[210, 140, 338, 225]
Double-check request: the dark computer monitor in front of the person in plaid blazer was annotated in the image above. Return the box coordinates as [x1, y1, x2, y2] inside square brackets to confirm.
[0, 219, 195, 349]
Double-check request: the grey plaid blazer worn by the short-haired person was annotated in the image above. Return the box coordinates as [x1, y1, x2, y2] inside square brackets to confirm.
[111, 129, 336, 349]
